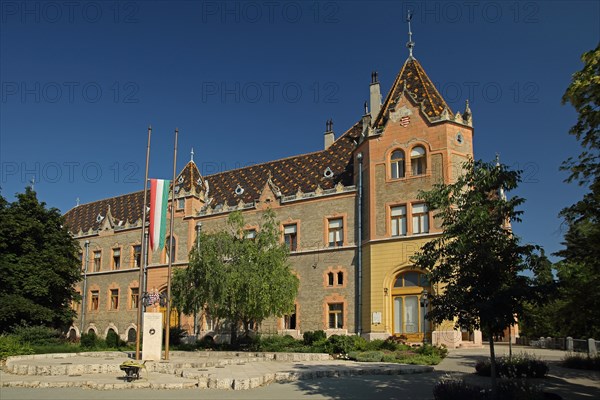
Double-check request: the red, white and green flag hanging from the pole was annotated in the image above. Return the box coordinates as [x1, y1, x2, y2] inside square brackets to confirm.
[150, 179, 171, 251]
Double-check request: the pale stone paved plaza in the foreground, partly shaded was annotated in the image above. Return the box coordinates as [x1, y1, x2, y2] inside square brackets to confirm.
[0, 345, 600, 400]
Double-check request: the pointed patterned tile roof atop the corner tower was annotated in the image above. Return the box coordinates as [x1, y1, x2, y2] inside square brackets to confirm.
[373, 57, 452, 126]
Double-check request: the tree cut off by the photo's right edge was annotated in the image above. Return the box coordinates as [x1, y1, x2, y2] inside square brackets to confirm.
[556, 45, 600, 337]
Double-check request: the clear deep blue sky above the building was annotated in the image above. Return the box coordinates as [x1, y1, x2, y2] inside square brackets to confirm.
[0, 0, 600, 260]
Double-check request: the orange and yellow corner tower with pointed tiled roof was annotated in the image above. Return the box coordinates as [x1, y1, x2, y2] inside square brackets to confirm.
[355, 18, 473, 346]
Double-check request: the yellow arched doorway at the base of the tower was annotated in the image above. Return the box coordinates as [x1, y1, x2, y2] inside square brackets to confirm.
[391, 270, 431, 342]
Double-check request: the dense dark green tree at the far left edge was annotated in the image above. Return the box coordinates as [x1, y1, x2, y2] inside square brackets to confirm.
[0, 187, 81, 332]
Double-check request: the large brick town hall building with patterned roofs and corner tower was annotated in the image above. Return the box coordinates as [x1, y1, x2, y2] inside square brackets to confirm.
[65, 42, 481, 347]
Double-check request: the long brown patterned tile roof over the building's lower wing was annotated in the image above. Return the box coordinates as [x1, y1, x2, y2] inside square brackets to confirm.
[65, 122, 362, 234]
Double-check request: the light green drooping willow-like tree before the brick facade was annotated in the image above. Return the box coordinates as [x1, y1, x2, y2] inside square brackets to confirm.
[173, 210, 299, 343]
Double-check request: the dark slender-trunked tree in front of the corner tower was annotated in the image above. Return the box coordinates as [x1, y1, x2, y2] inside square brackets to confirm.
[414, 160, 549, 389]
